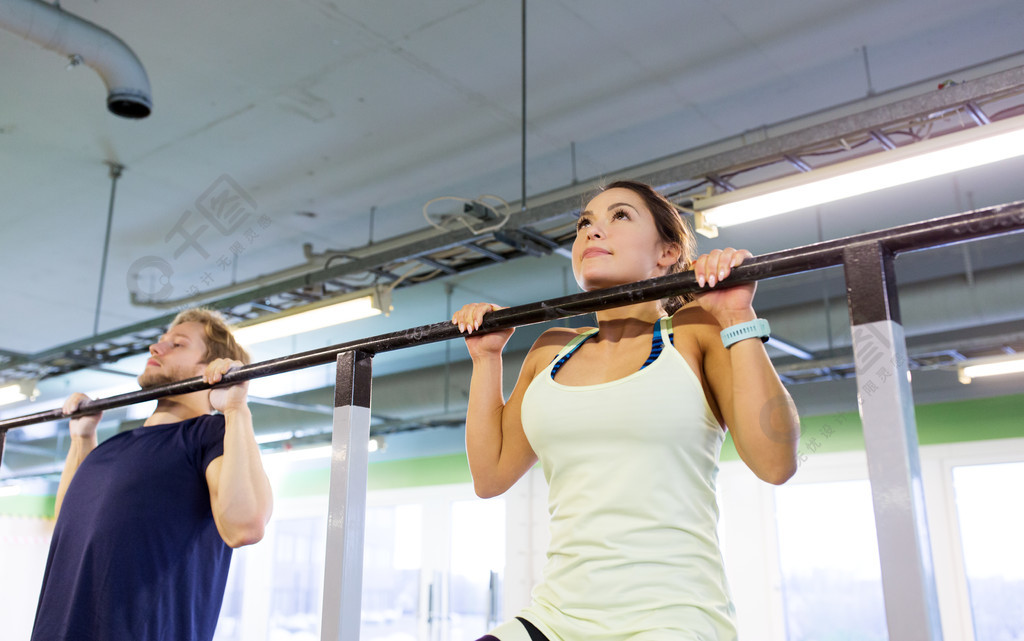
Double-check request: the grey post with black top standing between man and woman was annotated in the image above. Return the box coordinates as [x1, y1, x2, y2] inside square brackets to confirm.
[321, 351, 373, 641]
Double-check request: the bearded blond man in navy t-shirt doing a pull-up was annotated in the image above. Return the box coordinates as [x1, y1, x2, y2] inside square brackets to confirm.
[32, 309, 272, 641]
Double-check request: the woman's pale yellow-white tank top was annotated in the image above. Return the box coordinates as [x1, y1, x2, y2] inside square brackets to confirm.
[522, 317, 736, 641]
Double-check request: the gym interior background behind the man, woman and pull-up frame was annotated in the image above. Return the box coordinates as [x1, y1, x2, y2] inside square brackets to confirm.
[0, 0, 1024, 641]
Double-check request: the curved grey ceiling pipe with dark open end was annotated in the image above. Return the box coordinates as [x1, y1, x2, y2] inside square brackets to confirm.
[0, 0, 153, 119]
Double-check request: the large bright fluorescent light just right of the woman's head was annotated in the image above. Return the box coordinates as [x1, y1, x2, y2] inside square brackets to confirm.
[693, 111, 1024, 236]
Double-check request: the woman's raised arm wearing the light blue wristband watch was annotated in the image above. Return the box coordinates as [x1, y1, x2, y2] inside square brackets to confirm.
[694, 248, 800, 484]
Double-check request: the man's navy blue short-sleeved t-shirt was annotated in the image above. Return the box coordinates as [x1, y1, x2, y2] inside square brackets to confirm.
[32, 415, 231, 641]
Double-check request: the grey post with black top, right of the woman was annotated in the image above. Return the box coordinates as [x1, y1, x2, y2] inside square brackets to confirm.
[844, 243, 942, 641]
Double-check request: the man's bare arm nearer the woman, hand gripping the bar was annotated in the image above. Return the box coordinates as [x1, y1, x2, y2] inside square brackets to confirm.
[204, 358, 273, 548]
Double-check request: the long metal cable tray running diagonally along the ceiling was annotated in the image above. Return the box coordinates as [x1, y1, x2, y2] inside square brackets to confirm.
[6, 67, 1024, 383]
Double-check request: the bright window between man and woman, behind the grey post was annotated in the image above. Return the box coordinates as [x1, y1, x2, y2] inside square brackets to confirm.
[215, 484, 505, 641]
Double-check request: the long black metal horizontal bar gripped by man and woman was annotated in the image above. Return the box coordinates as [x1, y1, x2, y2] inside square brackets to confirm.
[0, 202, 1024, 430]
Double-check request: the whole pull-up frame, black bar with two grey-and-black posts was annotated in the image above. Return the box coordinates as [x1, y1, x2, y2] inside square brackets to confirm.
[0, 203, 1024, 641]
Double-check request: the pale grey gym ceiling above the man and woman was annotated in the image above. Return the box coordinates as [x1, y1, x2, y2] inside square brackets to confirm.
[0, 0, 1024, 477]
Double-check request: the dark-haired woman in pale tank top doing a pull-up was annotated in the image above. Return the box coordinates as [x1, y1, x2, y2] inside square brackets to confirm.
[452, 181, 800, 641]
